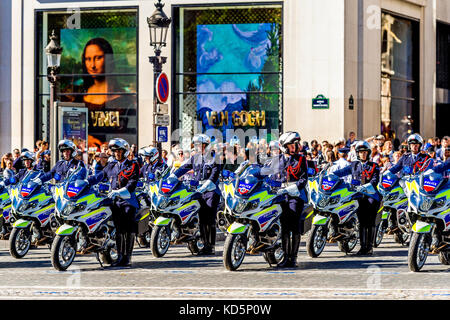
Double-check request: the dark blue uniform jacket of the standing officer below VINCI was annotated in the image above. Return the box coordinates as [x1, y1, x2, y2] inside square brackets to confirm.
[88, 159, 139, 209]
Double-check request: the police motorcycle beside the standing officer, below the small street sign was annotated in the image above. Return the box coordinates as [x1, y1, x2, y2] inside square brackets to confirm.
[306, 165, 376, 258]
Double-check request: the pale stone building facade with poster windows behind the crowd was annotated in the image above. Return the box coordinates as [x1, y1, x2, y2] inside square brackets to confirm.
[0, 0, 450, 153]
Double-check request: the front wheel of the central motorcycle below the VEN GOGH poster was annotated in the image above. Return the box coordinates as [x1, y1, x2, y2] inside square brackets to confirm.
[223, 233, 247, 271]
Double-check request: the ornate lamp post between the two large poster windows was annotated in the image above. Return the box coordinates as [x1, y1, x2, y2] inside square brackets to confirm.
[147, 0, 172, 157]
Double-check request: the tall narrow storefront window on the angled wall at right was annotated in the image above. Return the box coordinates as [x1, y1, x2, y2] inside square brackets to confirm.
[381, 13, 420, 142]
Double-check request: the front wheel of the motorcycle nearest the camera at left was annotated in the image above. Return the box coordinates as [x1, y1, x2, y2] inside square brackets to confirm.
[52, 235, 77, 271]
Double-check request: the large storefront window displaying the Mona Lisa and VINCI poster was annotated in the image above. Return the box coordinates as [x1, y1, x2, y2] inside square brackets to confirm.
[36, 8, 138, 151]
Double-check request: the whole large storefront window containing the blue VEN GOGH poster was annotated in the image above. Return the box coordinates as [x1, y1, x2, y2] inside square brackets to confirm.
[173, 5, 283, 148]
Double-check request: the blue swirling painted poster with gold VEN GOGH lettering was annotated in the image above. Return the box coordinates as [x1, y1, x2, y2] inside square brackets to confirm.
[197, 23, 280, 133]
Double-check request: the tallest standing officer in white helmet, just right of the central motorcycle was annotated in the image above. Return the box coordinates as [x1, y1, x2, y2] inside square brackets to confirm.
[263, 131, 308, 268]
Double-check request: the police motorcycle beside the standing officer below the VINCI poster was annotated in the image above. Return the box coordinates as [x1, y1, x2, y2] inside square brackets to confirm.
[51, 166, 117, 271]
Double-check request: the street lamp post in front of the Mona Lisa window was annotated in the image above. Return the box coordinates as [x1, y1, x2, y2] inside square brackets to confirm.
[45, 30, 63, 166]
